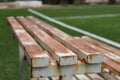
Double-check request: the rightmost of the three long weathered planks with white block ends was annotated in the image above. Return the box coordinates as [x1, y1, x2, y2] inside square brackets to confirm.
[27, 16, 103, 63]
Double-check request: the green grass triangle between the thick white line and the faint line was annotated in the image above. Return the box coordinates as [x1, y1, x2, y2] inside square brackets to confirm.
[59, 16, 120, 43]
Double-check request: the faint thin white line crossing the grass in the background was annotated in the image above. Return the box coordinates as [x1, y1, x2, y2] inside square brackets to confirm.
[53, 14, 120, 20]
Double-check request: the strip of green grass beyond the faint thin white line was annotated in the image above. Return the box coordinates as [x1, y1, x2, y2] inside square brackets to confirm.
[35, 5, 120, 17]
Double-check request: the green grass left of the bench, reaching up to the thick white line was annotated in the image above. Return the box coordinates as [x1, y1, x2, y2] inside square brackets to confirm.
[0, 9, 31, 80]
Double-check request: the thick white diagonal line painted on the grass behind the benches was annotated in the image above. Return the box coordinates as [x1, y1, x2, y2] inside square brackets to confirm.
[28, 9, 120, 48]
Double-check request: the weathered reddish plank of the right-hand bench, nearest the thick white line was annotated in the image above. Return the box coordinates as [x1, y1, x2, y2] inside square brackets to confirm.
[82, 36, 120, 56]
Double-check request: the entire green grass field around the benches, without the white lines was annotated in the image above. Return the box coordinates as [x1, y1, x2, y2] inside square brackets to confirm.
[0, 5, 120, 80]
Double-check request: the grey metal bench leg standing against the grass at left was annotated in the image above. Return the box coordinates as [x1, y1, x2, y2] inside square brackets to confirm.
[19, 45, 25, 80]
